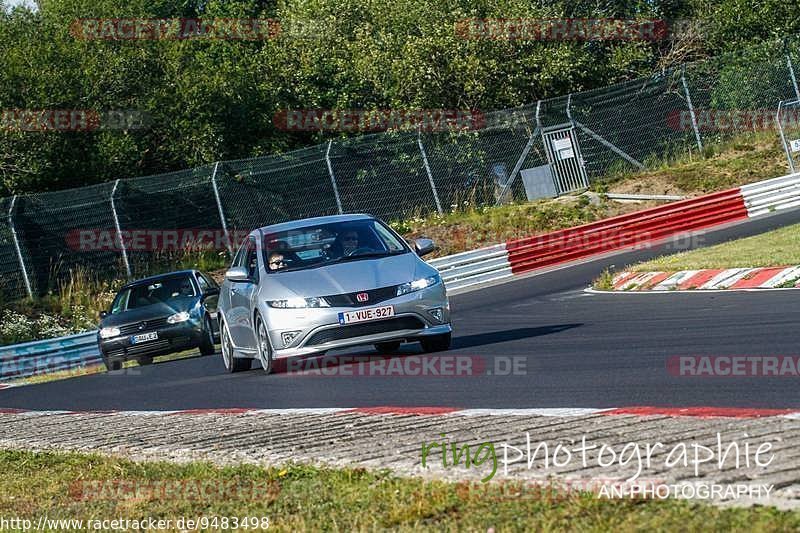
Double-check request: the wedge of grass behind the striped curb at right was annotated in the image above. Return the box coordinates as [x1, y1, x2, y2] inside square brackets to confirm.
[627, 224, 800, 272]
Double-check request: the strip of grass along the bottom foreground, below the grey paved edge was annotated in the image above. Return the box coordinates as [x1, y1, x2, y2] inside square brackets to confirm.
[0, 451, 800, 531]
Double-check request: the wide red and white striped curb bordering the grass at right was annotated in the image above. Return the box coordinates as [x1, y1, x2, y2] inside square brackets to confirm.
[612, 266, 800, 291]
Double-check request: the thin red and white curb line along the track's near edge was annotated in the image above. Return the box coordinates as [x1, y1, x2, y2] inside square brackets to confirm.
[0, 406, 800, 420]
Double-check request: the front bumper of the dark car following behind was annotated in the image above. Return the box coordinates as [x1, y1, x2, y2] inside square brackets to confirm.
[98, 321, 203, 361]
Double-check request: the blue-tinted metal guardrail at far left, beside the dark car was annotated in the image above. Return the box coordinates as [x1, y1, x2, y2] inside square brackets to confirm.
[0, 331, 102, 381]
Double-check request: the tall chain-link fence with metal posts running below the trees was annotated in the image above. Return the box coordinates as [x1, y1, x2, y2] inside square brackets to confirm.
[0, 35, 800, 298]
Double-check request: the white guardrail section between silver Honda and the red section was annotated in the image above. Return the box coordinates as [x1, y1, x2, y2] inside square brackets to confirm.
[428, 243, 512, 290]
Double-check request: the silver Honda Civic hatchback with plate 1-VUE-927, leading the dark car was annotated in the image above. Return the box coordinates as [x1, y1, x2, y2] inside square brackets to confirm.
[218, 215, 452, 373]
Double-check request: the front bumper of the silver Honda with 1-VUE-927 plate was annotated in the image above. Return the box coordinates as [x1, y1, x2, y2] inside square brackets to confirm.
[267, 283, 452, 359]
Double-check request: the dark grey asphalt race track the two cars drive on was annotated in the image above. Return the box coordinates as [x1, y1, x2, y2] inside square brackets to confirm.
[0, 206, 800, 411]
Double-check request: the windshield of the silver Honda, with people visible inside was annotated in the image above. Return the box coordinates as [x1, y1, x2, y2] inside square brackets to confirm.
[264, 219, 409, 273]
